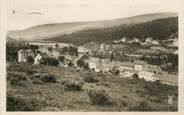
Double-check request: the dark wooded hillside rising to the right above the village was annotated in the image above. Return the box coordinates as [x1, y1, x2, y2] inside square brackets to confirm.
[47, 17, 178, 45]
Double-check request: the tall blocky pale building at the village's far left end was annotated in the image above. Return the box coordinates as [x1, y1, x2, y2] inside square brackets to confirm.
[18, 49, 34, 63]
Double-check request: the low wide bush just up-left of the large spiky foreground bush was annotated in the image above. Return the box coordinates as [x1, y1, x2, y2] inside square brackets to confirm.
[63, 81, 83, 91]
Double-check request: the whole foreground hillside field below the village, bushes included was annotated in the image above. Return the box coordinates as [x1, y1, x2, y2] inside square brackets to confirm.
[7, 62, 178, 111]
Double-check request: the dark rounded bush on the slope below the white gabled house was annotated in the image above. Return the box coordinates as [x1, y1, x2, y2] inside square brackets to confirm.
[41, 74, 56, 83]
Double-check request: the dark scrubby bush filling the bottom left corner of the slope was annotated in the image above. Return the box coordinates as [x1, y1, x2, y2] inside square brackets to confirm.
[6, 96, 37, 111]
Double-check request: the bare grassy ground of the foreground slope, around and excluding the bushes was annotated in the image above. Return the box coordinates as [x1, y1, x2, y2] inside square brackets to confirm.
[7, 63, 178, 111]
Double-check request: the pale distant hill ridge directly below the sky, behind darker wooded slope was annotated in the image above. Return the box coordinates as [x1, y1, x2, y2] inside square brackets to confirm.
[7, 13, 177, 41]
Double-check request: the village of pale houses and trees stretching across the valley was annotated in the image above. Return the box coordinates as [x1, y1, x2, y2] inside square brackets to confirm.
[17, 37, 178, 86]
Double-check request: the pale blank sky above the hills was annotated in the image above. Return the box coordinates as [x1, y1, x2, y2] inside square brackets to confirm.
[7, 0, 179, 30]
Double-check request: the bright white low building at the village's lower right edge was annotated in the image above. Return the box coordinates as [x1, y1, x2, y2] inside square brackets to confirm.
[138, 71, 159, 82]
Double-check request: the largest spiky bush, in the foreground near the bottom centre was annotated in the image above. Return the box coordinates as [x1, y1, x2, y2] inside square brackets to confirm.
[87, 89, 112, 105]
